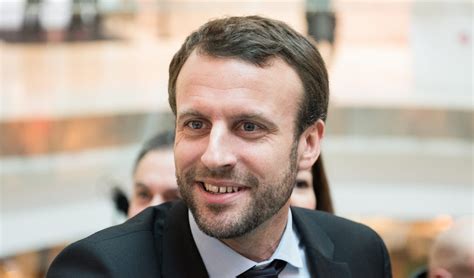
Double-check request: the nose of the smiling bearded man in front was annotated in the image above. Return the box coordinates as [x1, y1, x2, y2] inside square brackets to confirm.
[201, 125, 236, 170]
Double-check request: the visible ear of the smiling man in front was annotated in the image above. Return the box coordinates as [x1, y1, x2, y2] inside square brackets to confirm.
[298, 120, 325, 170]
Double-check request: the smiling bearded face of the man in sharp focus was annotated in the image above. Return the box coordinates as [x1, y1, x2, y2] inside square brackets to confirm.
[175, 52, 303, 239]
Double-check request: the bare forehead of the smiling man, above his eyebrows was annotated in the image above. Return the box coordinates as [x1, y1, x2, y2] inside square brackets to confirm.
[176, 52, 303, 117]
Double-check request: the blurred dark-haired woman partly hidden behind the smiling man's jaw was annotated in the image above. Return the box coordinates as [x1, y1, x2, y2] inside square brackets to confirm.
[291, 155, 334, 213]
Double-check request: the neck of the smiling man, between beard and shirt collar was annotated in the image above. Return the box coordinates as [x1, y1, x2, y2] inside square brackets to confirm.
[221, 202, 290, 262]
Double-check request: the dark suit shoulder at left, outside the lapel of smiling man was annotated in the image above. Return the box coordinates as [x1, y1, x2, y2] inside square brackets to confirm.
[47, 203, 181, 278]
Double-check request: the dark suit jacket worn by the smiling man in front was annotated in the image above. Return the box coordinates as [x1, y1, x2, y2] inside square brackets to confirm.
[47, 201, 391, 278]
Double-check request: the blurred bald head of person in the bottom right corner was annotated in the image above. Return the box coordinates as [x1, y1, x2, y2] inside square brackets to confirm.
[412, 217, 474, 278]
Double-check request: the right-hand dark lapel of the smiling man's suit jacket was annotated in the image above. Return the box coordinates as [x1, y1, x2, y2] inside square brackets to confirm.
[291, 208, 351, 278]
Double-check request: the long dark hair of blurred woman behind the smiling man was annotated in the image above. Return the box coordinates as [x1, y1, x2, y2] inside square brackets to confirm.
[311, 155, 334, 213]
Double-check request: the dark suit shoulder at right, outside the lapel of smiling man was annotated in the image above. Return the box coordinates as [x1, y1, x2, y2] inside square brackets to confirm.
[292, 208, 391, 277]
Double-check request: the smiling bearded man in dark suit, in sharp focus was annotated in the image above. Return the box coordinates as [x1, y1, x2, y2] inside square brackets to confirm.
[48, 16, 391, 278]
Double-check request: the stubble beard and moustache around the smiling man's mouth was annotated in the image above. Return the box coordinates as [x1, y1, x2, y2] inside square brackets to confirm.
[176, 142, 297, 239]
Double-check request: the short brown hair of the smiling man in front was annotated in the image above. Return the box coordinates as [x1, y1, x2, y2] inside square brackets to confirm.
[168, 16, 329, 136]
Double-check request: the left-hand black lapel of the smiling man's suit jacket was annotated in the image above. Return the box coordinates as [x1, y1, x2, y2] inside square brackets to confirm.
[161, 201, 208, 278]
